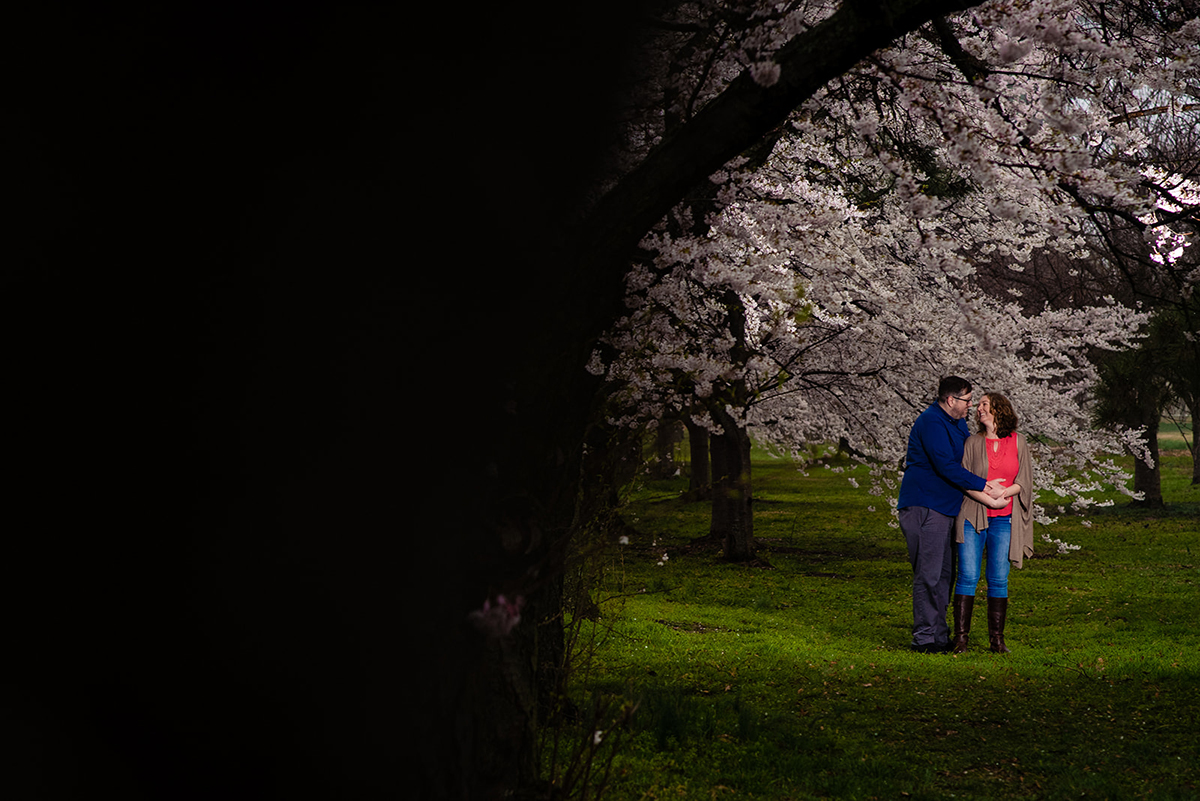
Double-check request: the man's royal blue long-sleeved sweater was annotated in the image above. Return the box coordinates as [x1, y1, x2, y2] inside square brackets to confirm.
[896, 403, 988, 516]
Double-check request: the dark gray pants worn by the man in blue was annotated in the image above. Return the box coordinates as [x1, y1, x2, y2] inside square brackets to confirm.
[899, 506, 954, 649]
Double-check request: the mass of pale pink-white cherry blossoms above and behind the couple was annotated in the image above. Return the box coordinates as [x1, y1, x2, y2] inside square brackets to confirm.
[589, 0, 1200, 532]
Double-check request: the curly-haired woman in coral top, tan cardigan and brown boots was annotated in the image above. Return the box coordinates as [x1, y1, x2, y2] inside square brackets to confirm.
[953, 392, 1033, 654]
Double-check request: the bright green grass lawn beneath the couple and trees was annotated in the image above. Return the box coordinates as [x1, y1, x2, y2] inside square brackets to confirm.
[554, 448, 1200, 799]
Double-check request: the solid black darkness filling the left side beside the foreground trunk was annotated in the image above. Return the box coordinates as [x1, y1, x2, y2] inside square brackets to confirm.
[7, 1, 648, 800]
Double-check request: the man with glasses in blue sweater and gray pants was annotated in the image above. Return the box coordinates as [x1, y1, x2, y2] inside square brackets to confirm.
[896, 375, 1003, 654]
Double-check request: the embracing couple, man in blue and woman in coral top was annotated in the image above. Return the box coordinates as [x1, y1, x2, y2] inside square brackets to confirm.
[896, 375, 1033, 654]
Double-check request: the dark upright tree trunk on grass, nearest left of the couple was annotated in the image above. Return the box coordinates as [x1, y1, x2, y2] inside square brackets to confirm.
[710, 410, 755, 561]
